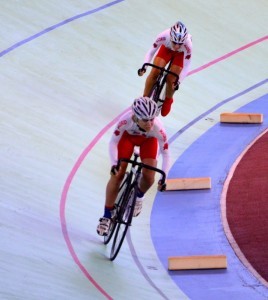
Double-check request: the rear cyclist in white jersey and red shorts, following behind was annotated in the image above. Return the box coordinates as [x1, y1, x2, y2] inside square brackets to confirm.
[138, 21, 192, 116]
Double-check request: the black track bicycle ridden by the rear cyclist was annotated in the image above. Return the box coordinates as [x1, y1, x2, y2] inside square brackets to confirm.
[138, 60, 179, 112]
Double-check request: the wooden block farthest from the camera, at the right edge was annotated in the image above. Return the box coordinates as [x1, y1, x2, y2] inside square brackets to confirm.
[220, 113, 263, 123]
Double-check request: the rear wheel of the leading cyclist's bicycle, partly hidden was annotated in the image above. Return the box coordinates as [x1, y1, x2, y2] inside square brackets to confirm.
[103, 173, 131, 245]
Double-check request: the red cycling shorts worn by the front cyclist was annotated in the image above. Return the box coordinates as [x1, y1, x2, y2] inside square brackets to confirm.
[117, 131, 158, 160]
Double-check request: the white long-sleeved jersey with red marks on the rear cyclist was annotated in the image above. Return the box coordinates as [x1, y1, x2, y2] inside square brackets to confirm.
[144, 28, 192, 82]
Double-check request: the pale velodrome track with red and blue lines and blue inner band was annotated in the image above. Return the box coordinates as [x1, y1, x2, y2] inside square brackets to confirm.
[0, 0, 267, 299]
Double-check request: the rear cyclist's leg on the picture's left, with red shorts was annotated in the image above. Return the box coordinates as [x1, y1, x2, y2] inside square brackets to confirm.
[143, 45, 171, 96]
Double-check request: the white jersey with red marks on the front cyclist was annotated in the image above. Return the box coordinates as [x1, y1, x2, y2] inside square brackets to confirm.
[109, 111, 170, 175]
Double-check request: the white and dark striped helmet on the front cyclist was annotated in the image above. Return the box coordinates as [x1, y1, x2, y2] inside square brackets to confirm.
[132, 97, 157, 120]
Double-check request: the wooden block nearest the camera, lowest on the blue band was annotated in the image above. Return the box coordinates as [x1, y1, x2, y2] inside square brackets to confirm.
[168, 255, 227, 271]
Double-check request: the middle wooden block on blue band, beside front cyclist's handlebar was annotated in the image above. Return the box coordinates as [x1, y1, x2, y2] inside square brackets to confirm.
[166, 177, 211, 191]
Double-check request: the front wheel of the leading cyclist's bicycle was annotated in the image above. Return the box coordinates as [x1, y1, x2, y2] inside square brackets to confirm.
[110, 185, 137, 260]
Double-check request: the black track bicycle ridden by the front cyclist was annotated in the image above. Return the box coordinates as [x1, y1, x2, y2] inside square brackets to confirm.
[104, 153, 166, 261]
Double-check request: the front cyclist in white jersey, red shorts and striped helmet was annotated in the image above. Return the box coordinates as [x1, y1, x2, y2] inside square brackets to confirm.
[97, 97, 169, 235]
